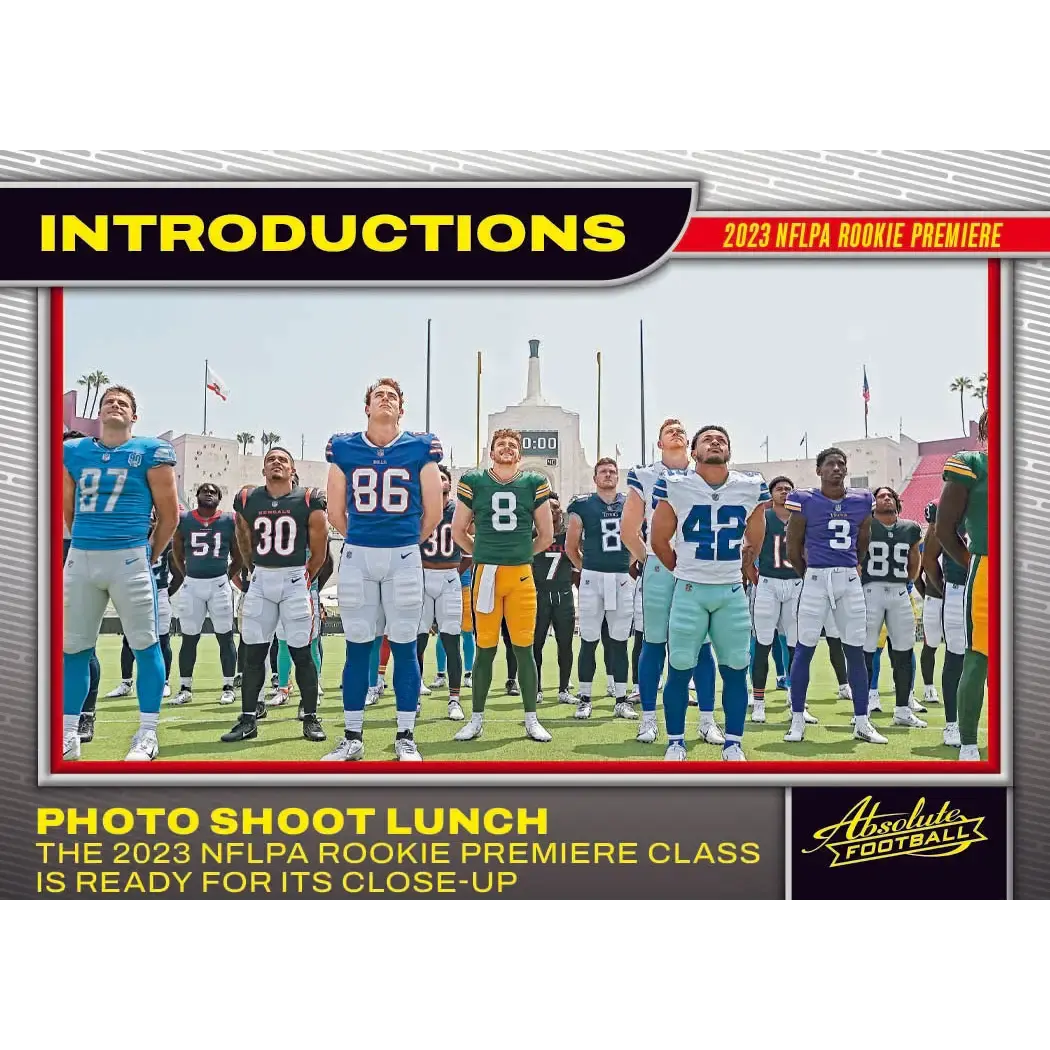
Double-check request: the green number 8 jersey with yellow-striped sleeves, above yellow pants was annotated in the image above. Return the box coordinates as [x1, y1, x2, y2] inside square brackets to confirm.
[456, 470, 550, 566]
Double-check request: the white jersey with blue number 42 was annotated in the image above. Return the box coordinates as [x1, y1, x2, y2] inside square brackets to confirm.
[653, 470, 770, 585]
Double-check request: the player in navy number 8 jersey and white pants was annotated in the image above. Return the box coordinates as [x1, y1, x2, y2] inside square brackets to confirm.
[565, 457, 637, 718]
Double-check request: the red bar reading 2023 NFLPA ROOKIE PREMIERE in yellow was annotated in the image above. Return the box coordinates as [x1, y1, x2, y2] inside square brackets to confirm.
[674, 213, 1050, 255]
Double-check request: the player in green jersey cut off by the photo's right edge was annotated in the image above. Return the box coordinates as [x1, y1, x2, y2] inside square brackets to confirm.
[935, 408, 990, 762]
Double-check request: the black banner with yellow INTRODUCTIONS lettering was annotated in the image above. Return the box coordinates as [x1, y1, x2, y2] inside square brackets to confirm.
[0, 183, 696, 286]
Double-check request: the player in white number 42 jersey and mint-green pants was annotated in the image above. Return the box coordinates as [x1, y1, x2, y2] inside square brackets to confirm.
[651, 425, 770, 762]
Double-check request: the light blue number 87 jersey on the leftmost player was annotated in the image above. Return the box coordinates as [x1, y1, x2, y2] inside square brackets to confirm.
[62, 438, 175, 550]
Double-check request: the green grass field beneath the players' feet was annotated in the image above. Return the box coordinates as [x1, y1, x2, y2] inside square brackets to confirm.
[82, 635, 987, 762]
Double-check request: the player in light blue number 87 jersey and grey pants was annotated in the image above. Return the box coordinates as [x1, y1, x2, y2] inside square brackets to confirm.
[62, 386, 179, 761]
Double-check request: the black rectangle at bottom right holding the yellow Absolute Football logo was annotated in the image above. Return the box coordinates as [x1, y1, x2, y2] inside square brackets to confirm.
[790, 788, 1010, 904]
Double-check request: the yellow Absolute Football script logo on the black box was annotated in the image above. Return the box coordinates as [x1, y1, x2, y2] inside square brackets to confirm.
[802, 795, 988, 867]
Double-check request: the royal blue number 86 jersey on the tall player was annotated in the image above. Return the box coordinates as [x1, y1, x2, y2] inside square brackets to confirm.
[324, 433, 444, 550]
